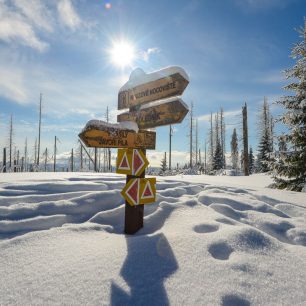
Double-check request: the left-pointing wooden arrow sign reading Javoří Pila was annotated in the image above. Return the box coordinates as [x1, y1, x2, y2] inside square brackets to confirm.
[79, 128, 156, 150]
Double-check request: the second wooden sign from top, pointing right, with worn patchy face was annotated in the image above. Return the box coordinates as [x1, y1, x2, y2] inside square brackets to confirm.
[117, 97, 189, 129]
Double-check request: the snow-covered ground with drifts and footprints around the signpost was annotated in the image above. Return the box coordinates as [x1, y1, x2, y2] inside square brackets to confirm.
[0, 173, 306, 306]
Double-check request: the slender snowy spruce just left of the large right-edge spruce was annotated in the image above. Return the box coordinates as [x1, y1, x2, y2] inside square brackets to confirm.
[258, 97, 273, 172]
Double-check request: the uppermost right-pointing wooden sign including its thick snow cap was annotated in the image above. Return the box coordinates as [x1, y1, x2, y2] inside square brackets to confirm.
[118, 66, 189, 110]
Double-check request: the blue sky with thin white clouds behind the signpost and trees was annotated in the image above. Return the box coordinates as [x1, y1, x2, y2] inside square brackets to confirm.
[0, 0, 306, 166]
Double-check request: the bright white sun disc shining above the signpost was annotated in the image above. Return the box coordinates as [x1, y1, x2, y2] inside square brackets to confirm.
[110, 41, 135, 68]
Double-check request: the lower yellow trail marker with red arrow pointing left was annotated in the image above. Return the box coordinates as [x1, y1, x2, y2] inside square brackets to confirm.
[121, 178, 156, 206]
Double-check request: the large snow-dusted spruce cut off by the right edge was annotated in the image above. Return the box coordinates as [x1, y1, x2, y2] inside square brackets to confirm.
[272, 19, 306, 191]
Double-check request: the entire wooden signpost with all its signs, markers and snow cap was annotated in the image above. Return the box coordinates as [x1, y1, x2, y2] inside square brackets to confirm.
[79, 66, 189, 234]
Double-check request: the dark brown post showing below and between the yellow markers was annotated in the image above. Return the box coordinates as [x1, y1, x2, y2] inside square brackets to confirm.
[124, 149, 146, 235]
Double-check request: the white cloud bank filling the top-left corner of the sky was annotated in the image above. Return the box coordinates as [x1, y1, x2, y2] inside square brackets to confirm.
[0, 0, 86, 52]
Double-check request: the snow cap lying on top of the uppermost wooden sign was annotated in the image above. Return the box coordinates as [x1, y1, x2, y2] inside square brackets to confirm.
[119, 66, 189, 92]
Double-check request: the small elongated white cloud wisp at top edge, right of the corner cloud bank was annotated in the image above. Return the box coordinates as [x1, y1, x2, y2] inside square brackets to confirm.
[57, 0, 82, 30]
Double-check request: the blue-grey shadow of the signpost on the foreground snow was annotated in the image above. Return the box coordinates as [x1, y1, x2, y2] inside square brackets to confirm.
[111, 234, 178, 306]
